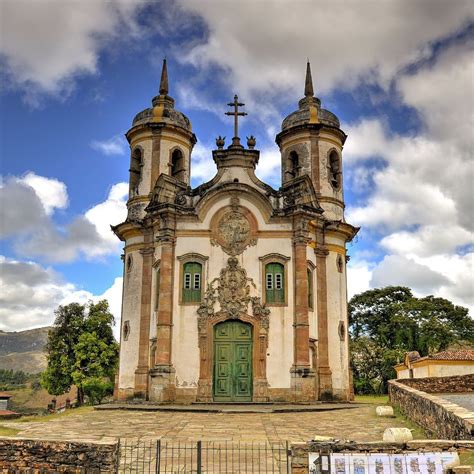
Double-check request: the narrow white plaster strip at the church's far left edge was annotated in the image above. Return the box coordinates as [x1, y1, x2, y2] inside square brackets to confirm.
[119, 250, 143, 388]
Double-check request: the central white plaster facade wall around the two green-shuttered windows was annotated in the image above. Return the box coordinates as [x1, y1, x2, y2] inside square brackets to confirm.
[172, 196, 294, 388]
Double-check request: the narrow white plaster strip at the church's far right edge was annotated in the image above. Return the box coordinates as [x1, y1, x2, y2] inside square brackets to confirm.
[326, 251, 349, 391]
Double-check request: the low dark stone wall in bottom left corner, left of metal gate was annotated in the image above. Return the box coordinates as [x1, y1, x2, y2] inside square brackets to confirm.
[0, 437, 118, 474]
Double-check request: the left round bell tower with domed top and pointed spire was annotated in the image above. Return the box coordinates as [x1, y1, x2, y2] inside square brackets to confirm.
[126, 59, 196, 217]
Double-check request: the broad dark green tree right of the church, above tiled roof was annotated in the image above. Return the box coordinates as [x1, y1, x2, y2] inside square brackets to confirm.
[349, 286, 474, 393]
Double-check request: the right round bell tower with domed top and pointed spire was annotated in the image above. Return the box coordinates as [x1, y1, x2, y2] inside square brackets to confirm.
[276, 62, 346, 223]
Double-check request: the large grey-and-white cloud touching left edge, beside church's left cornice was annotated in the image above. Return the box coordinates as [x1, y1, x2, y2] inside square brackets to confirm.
[0, 173, 128, 263]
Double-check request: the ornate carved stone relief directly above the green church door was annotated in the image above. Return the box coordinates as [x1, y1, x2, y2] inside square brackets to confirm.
[198, 257, 270, 331]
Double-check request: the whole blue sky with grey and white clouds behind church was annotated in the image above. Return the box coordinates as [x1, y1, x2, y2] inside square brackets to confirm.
[0, 0, 474, 336]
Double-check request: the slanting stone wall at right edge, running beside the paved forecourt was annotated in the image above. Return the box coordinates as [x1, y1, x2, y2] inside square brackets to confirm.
[388, 380, 474, 440]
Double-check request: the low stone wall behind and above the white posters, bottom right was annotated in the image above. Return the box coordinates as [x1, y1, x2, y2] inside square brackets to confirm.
[291, 440, 474, 474]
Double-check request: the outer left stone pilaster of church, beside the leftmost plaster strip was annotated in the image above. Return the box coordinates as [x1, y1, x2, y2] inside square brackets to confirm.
[134, 232, 154, 398]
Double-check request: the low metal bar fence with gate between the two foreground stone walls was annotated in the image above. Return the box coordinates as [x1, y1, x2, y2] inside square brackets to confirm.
[118, 439, 290, 474]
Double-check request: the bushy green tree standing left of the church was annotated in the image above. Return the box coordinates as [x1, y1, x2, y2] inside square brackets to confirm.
[41, 300, 118, 405]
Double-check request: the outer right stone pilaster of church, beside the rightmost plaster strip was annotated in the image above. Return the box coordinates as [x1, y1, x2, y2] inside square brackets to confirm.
[314, 228, 332, 400]
